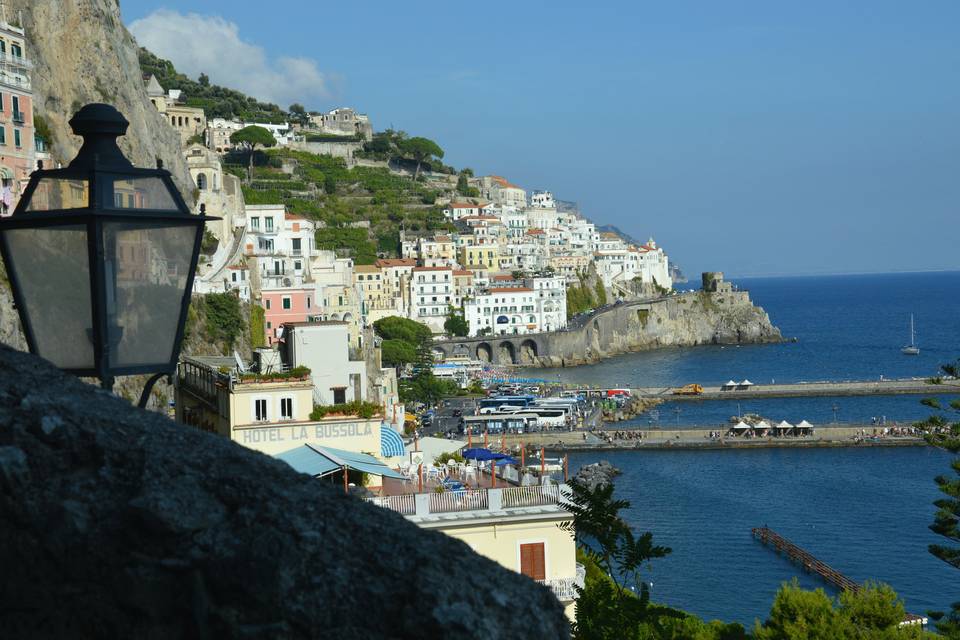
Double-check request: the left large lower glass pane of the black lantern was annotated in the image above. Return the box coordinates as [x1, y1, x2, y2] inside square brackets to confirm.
[4, 225, 94, 369]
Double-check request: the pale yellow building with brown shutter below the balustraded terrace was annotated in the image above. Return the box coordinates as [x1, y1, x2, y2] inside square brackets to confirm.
[370, 485, 585, 620]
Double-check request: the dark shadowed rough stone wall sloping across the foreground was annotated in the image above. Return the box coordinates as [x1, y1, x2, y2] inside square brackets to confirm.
[0, 347, 569, 640]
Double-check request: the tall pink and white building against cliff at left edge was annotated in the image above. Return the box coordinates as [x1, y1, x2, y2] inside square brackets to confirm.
[0, 22, 36, 216]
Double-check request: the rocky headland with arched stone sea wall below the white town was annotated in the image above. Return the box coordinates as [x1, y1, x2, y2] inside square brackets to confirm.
[434, 291, 783, 367]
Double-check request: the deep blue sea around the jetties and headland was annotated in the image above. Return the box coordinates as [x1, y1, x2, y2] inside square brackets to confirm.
[527, 272, 960, 625]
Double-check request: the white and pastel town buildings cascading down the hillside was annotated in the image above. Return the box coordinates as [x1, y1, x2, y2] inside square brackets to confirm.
[0, 17, 672, 620]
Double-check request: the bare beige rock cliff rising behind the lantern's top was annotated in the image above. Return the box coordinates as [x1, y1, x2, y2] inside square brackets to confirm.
[12, 0, 194, 190]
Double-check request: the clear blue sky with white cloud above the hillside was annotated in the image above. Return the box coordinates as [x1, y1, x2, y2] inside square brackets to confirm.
[121, 0, 960, 276]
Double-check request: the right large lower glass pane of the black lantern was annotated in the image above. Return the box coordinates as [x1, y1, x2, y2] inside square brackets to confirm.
[103, 219, 202, 367]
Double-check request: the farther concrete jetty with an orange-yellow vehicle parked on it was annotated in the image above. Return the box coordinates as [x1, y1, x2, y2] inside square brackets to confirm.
[633, 378, 960, 402]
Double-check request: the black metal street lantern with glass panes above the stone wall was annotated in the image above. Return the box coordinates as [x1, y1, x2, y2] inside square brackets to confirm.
[0, 104, 216, 406]
